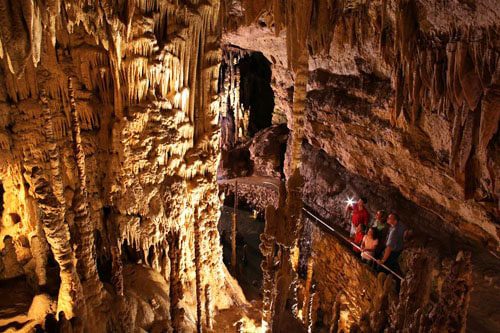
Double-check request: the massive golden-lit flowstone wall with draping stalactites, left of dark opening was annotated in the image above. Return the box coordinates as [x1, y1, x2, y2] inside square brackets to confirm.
[0, 0, 231, 332]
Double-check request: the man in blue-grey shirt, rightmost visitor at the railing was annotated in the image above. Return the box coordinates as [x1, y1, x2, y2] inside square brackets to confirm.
[377, 213, 405, 272]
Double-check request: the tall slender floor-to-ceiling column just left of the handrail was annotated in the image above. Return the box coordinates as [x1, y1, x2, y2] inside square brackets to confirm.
[266, 0, 312, 329]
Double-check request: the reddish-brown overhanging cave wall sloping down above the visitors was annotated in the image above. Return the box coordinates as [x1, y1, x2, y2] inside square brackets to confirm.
[223, 0, 500, 251]
